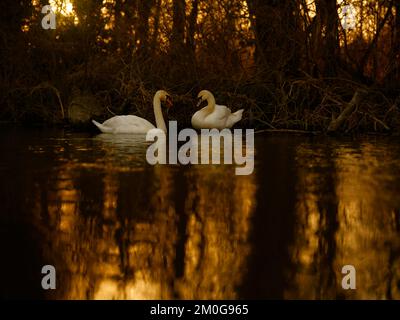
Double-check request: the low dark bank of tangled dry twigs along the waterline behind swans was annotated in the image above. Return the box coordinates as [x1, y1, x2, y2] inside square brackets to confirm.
[0, 79, 400, 135]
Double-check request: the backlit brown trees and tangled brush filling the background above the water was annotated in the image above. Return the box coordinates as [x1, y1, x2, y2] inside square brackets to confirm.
[0, 0, 400, 132]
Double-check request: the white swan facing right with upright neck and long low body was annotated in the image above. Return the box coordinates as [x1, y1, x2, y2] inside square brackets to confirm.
[92, 90, 172, 133]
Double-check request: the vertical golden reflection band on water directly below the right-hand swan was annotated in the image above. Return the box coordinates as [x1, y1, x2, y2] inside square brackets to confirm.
[180, 167, 255, 299]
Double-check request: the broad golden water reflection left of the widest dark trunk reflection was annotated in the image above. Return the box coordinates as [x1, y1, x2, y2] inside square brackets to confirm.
[35, 136, 255, 299]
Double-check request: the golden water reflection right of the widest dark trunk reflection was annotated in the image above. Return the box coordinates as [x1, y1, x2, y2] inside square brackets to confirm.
[285, 143, 400, 299]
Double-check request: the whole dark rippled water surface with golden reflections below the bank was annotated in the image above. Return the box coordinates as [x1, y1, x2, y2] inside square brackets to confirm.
[0, 129, 400, 299]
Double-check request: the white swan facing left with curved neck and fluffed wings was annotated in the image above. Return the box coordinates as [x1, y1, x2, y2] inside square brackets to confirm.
[192, 90, 243, 130]
